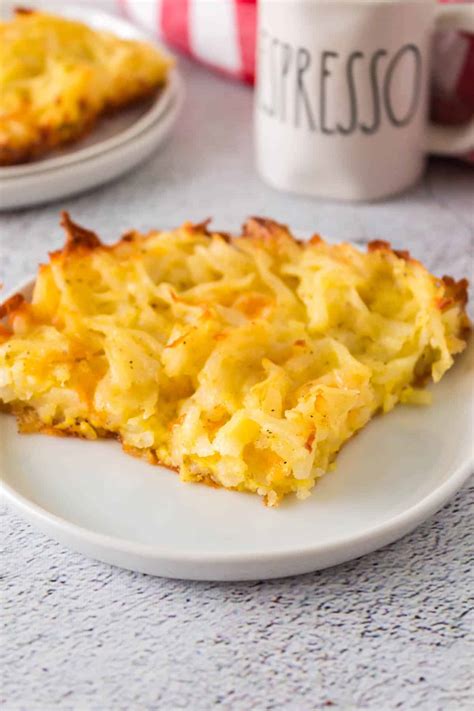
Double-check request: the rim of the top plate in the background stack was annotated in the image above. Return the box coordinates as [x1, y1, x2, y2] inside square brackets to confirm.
[0, 3, 178, 181]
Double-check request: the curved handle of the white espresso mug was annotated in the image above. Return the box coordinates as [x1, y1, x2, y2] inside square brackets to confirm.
[426, 3, 474, 155]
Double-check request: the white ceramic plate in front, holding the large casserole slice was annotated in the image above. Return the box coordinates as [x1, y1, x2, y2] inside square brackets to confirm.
[0, 278, 474, 580]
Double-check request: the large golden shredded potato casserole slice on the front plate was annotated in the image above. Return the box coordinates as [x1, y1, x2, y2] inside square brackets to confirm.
[0, 215, 468, 506]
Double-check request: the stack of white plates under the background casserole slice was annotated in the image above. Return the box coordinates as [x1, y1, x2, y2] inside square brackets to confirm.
[0, 7, 184, 210]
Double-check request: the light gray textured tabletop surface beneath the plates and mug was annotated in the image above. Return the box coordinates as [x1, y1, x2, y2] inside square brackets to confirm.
[0, 46, 474, 711]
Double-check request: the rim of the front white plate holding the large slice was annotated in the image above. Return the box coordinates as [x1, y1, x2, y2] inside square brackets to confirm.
[0, 277, 474, 580]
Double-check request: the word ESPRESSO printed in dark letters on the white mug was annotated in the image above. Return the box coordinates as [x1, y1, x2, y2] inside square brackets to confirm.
[258, 30, 422, 136]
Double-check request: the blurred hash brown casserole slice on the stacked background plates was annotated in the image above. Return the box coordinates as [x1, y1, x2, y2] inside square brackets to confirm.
[0, 10, 172, 165]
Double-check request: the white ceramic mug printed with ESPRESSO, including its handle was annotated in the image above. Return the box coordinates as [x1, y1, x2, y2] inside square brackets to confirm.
[254, 0, 474, 200]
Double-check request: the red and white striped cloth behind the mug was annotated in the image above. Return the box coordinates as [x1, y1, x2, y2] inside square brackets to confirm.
[117, 0, 474, 161]
